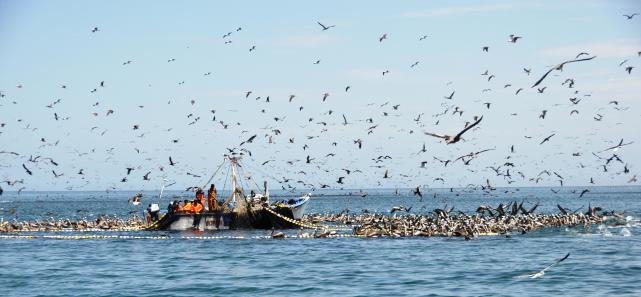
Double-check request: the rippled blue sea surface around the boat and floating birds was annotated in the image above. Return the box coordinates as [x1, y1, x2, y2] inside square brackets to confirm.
[0, 187, 641, 296]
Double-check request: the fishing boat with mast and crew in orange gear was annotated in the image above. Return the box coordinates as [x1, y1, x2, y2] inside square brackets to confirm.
[147, 154, 311, 231]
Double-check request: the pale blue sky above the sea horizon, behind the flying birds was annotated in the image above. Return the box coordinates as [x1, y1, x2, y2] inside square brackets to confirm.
[0, 1, 641, 191]
